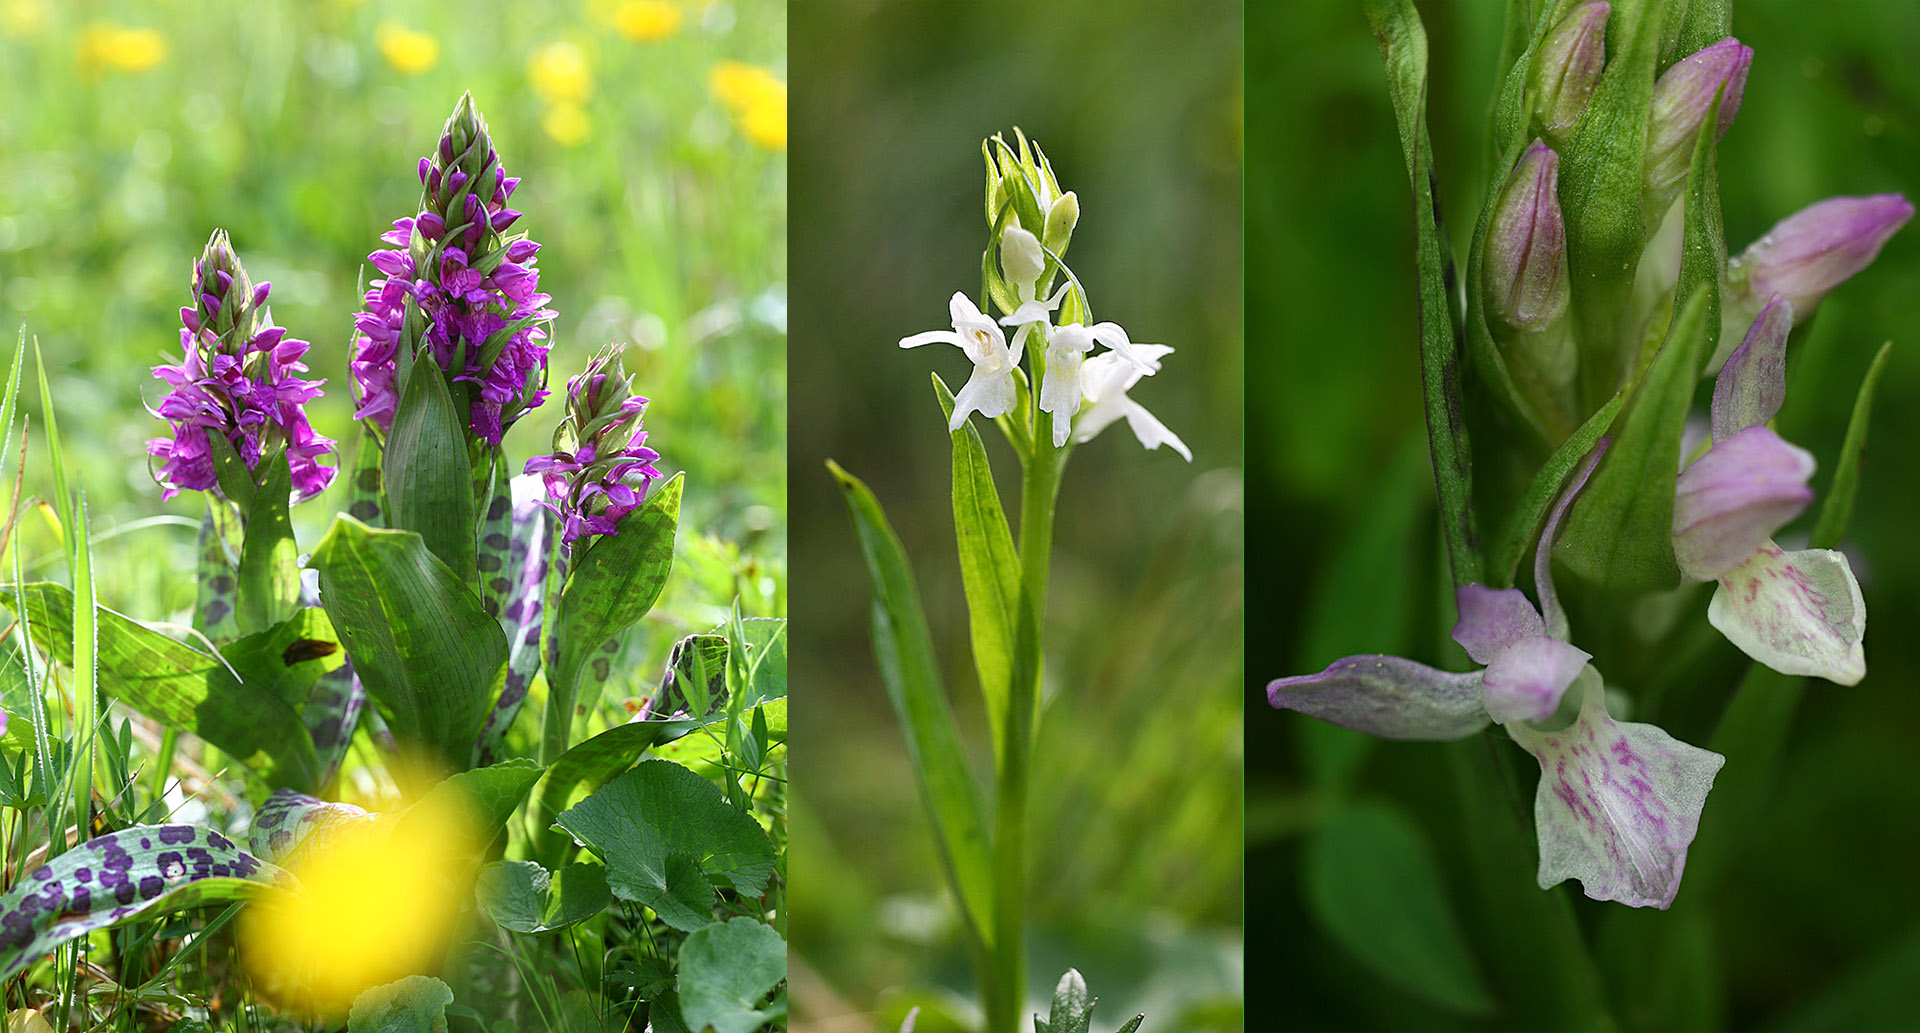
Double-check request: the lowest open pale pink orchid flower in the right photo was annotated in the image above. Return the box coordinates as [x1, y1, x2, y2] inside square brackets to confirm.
[1267, 440, 1726, 908]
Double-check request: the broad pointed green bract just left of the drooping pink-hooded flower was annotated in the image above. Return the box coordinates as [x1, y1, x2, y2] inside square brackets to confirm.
[1555, 292, 1709, 588]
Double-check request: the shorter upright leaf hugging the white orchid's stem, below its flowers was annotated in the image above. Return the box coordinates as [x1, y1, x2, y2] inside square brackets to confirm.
[933, 374, 1020, 766]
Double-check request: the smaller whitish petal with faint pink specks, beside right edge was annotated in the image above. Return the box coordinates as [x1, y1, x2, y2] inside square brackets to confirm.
[1707, 541, 1866, 685]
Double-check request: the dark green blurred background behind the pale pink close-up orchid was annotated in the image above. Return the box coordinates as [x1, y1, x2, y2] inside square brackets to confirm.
[1246, 0, 1920, 1029]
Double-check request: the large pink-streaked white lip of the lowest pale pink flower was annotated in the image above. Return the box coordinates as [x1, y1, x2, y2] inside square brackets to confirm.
[1507, 668, 1726, 898]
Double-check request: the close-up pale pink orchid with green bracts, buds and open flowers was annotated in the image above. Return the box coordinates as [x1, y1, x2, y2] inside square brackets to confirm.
[1267, 0, 1912, 908]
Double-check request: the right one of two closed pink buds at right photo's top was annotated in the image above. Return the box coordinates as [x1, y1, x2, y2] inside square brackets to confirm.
[1644, 36, 1753, 219]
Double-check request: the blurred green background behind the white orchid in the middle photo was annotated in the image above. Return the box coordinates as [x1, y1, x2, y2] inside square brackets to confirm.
[789, 2, 1242, 1031]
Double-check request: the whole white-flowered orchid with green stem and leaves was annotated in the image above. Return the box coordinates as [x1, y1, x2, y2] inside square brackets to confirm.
[831, 131, 1192, 1029]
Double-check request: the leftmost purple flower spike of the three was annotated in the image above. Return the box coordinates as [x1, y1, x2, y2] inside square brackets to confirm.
[146, 230, 338, 501]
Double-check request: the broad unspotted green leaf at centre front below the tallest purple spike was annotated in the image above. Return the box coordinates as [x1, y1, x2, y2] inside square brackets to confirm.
[313, 514, 507, 770]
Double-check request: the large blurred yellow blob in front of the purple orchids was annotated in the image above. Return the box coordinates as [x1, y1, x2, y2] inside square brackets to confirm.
[240, 797, 484, 1016]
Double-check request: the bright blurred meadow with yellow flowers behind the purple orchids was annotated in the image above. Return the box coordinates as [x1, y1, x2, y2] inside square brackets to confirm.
[0, 0, 787, 633]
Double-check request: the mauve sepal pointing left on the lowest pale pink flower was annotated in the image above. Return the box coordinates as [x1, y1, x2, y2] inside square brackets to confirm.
[1267, 655, 1490, 739]
